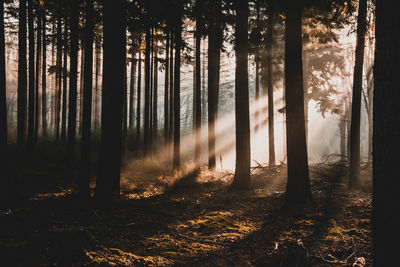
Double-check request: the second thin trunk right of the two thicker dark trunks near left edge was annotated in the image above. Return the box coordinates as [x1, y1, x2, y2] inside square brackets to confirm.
[42, 12, 47, 139]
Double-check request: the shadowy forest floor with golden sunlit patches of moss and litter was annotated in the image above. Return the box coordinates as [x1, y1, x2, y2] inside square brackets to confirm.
[0, 152, 372, 267]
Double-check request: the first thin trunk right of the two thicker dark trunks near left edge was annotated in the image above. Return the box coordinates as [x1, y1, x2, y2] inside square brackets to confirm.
[34, 11, 42, 144]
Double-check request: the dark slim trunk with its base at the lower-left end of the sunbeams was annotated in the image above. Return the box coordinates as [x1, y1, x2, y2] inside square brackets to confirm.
[173, 23, 183, 169]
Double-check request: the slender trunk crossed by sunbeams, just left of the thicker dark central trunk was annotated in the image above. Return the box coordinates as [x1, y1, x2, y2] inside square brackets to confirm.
[194, 11, 201, 166]
